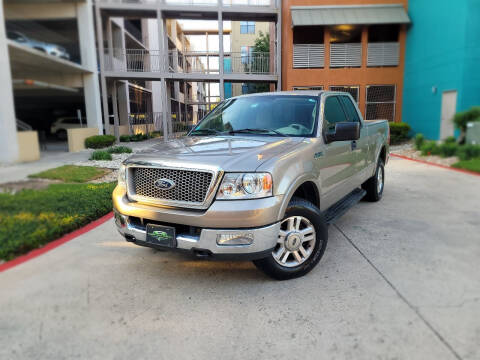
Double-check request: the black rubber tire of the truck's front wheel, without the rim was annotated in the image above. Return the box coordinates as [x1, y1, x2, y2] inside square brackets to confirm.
[253, 198, 328, 280]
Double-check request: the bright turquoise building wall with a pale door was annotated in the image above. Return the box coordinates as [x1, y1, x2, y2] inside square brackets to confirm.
[403, 0, 480, 140]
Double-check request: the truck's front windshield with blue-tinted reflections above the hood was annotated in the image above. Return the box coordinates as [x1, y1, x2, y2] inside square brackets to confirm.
[190, 95, 318, 137]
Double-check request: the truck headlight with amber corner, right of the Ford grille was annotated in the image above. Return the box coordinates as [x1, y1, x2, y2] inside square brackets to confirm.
[217, 173, 273, 200]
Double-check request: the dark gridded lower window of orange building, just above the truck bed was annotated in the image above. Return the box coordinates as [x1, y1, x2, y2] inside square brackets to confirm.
[365, 85, 396, 121]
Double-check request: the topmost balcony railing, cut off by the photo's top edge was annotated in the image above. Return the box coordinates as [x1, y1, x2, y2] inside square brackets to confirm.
[95, 0, 276, 7]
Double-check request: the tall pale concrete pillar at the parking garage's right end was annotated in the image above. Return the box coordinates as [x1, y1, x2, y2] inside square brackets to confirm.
[77, 0, 103, 134]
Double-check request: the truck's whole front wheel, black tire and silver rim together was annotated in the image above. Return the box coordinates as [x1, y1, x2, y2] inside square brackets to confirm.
[253, 198, 328, 280]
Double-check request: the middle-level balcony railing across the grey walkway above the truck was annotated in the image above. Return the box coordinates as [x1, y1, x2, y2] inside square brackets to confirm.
[105, 49, 275, 75]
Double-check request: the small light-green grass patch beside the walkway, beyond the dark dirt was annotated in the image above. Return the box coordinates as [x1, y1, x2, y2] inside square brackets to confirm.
[29, 165, 108, 183]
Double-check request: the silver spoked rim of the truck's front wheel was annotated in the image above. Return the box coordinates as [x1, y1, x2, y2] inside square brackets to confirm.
[272, 216, 317, 267]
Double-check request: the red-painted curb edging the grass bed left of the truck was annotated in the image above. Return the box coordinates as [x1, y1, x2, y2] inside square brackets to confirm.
[0, 212, 113, 272]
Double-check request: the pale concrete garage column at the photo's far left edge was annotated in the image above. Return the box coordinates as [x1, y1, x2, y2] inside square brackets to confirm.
[0, 2, 19, 163]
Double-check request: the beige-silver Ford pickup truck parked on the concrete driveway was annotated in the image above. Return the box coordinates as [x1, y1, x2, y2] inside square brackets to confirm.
[113, 91, 389, 279]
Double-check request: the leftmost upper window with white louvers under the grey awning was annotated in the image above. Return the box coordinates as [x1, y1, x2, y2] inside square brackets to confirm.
[293, 26, 325, 69]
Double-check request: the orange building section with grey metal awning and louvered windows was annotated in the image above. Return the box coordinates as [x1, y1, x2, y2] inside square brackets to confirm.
[282, 0, 410, 121]
